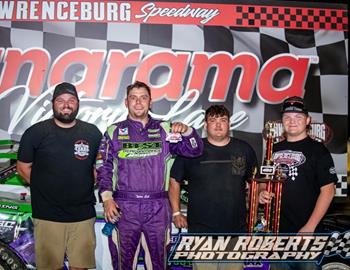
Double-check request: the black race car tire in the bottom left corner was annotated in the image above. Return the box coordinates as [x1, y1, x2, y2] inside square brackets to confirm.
[0, 241, 27, 270]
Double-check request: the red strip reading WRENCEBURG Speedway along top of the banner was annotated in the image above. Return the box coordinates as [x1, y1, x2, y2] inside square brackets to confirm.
[0, 0, 348, 31]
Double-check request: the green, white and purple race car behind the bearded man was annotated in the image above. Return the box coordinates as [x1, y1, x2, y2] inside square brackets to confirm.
[0, 140, 35, 270]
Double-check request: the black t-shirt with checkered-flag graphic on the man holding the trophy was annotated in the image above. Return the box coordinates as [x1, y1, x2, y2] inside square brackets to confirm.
[272, 137, 338, 233]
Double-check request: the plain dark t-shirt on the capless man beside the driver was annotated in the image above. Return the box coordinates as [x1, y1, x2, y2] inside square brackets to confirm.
[171, 138, 257, 233]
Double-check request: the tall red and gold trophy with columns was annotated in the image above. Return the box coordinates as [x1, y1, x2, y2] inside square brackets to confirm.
[248, 121, 284, 233]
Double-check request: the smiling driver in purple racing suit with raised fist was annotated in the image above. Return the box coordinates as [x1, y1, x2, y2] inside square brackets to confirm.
[97, 81, 203, 270]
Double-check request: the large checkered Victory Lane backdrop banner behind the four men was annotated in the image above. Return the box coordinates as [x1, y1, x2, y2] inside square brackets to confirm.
[0, 1, 348, 196]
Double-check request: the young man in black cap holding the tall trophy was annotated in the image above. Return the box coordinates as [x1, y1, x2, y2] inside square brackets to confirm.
[259, 97, 337, 270]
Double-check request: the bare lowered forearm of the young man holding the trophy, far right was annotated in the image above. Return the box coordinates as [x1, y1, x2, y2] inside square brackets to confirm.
[299, 183, 335, 233]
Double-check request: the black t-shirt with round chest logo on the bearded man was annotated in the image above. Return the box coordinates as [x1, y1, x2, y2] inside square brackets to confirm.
[18, 119, 102, 222]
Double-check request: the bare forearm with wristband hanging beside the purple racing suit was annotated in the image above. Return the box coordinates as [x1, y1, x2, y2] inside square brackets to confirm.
[168, 178, 187, 228]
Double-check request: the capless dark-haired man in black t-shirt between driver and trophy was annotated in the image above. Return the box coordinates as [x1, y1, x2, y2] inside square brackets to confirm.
[169, 105, 257, 269]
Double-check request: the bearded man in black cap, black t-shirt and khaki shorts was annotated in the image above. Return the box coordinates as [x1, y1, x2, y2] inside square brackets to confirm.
[17, 83, 102, 270]
